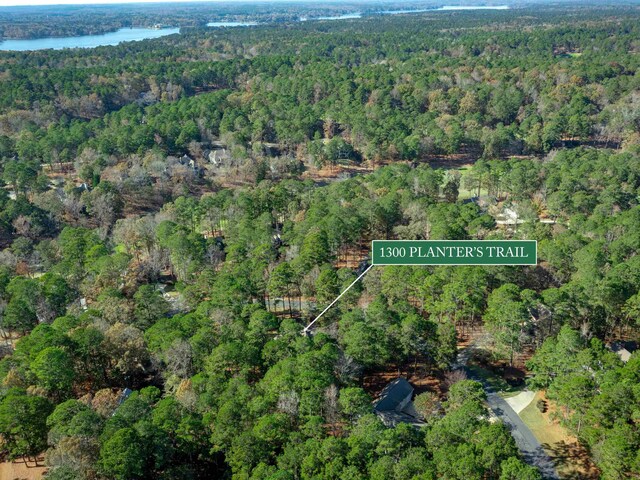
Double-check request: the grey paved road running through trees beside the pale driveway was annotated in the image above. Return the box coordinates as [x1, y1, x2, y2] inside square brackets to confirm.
[457, 346, 560, 480]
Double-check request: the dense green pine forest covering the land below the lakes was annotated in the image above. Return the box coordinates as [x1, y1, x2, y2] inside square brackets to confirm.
[0, 5, 640, 480]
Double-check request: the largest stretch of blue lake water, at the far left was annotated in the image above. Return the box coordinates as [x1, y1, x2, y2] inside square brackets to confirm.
[0, 28, 180, 51]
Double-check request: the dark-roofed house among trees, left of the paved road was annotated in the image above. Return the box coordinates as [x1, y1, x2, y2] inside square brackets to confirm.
[373, 377, 424, 427]
